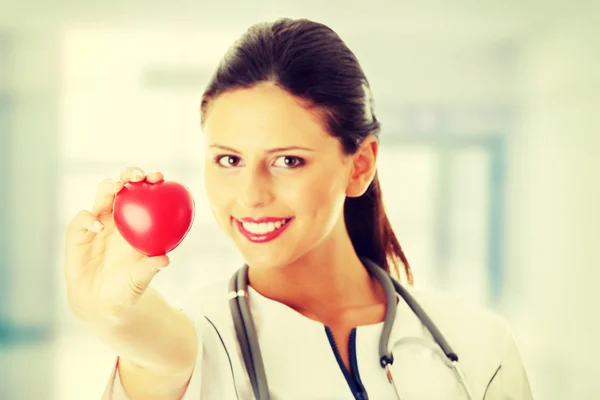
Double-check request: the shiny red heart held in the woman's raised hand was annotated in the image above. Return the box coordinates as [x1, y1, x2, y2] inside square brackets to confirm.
[113, 181, 194, 257]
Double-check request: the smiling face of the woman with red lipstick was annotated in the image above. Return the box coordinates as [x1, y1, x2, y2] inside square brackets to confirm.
[203, 84, 366, 267]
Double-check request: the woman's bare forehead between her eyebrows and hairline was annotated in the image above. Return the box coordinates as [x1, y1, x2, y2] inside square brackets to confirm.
[203, 84, 334, 148]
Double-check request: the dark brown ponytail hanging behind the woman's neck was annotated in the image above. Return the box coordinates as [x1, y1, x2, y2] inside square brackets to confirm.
[344, 173, 413, 285]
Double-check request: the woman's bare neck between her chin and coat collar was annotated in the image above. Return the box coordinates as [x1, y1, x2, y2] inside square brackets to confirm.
[248, 219, 385, 317]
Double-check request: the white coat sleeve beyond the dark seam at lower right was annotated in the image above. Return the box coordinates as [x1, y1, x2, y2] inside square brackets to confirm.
[484, 324, 533, 400]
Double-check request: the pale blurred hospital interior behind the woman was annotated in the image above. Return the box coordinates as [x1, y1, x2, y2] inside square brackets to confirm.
[0, 0, 600, 400]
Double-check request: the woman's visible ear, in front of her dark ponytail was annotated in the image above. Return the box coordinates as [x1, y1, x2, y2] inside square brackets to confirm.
[346, 135, 379, 197]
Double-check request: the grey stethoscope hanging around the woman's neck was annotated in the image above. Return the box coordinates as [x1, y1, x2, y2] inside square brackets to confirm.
[229, 258, 474, 400]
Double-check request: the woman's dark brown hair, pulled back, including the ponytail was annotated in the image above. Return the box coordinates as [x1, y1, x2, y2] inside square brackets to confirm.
[201, 18, 412, 283]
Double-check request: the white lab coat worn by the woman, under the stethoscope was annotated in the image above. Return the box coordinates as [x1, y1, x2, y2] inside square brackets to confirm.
[103, 282, 532, 400]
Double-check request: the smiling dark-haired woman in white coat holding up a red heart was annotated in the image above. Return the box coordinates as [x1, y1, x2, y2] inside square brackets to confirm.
[65, 19, 531, 400]
